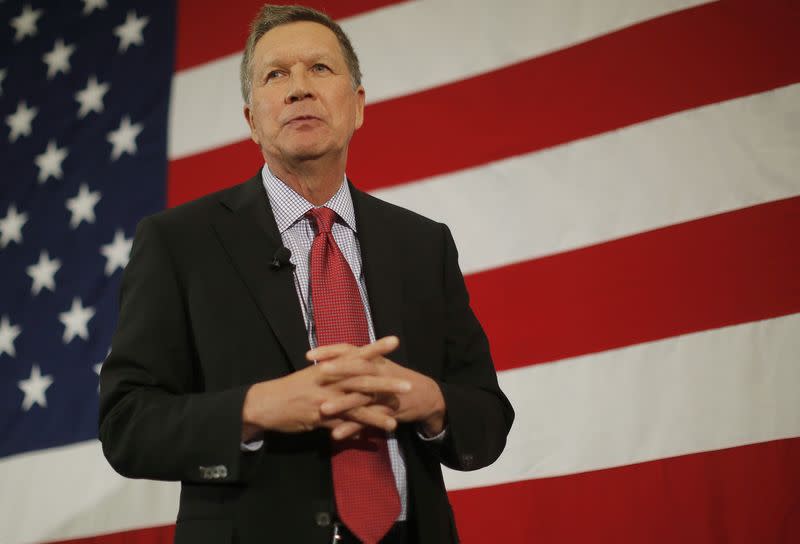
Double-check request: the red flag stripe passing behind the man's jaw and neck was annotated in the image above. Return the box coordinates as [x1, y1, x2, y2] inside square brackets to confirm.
[168, 0, 800, 205]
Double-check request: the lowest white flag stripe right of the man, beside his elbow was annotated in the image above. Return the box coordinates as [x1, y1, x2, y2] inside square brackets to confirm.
[445, 314, 800, 490]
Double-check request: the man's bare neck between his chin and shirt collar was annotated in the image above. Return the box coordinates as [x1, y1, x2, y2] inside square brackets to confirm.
[267, 155, 344, 206]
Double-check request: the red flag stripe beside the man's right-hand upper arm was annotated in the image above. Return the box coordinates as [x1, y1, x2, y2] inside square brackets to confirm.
[467, 197, 800, 370]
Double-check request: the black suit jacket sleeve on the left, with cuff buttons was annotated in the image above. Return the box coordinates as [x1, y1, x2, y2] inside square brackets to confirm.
[100, 218, 252, 483]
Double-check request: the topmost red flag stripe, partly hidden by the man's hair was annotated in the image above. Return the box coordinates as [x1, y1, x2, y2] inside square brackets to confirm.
[175, 0, 403, 70]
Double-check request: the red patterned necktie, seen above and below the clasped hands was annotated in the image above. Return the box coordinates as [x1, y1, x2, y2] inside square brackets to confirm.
[306, 207, 400, 544]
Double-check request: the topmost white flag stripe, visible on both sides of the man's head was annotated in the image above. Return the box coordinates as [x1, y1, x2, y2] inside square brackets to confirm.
[168, 0, 707, 159]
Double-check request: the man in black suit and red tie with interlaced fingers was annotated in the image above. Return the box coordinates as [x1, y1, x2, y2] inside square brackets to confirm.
[100, 6, 513, 544]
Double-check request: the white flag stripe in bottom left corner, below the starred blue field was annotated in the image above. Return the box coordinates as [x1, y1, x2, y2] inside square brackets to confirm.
[0, 440, 180, 544]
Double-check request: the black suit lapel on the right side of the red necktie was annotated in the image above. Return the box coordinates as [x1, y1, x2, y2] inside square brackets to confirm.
[350, 184, 413, 367]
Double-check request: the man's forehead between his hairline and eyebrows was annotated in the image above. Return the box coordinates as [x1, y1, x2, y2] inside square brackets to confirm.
[255, 21, 343, 62]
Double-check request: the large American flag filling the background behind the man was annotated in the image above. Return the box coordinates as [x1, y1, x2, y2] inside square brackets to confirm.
[0, 0, 800, 544]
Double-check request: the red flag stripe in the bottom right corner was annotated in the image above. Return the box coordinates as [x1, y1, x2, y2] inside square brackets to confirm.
[450, 437, 800, 544]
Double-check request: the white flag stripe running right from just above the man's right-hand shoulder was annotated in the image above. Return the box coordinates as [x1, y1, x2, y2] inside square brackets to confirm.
[374, 84, 800, 273]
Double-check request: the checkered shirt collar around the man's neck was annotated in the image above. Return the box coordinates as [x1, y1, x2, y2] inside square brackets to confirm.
[261, 164, 358, 234]
